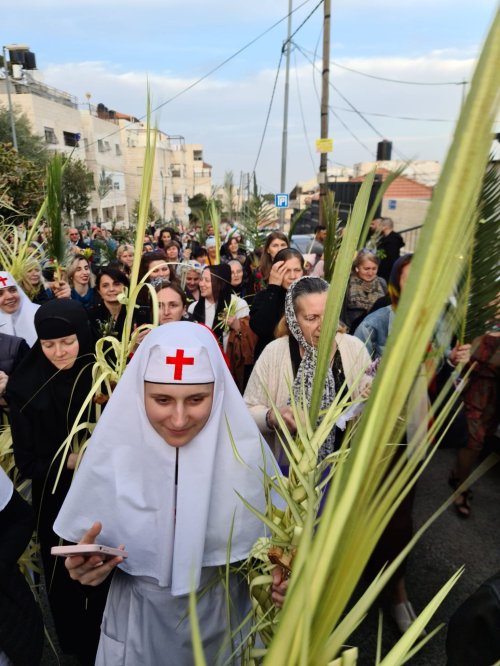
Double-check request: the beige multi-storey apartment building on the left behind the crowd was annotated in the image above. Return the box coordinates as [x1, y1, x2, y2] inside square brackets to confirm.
[0, 55, 212, 226]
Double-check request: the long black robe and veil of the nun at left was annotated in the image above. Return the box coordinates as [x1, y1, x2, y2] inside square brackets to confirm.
[7, 299, 107, 665]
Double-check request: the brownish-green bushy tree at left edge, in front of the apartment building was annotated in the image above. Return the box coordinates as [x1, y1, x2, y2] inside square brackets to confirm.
[0, 143, 45, 224]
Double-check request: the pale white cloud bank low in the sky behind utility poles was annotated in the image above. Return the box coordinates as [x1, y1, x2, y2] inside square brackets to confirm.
[40, 51, 480, 190]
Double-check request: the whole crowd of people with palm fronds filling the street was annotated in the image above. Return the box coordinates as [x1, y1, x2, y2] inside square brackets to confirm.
[0, 219, 500, 666]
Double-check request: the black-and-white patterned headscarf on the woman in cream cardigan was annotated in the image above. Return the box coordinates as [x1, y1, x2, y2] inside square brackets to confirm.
[285, 275, 335, 461]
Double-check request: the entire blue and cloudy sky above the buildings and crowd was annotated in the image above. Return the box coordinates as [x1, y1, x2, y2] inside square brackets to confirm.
[0, 0, 500, 192]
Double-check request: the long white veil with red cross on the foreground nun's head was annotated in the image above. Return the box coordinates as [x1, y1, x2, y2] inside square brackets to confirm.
[54, 322, 273, 595]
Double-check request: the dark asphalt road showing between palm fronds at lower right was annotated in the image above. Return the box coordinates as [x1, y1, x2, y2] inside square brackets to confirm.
[42, 440, 500, 666]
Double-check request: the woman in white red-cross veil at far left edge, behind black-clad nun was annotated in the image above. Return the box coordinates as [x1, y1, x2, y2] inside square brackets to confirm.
[0, 271, 40, 347]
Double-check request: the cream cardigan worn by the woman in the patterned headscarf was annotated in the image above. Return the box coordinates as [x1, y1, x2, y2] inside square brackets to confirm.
[243, 333, 370, 455]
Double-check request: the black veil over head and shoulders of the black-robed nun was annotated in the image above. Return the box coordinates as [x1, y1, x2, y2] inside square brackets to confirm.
[7, 298, 93, 428]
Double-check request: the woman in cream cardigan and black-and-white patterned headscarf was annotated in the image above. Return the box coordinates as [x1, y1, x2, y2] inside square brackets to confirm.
[243, 277, 371, 466]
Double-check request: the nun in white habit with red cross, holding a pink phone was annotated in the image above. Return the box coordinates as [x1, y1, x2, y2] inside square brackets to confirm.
[54, 322, 273, 666]
